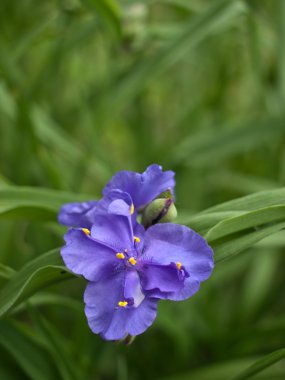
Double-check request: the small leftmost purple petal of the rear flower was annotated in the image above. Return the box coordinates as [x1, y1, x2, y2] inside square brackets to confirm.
[58, 201, 98, 228]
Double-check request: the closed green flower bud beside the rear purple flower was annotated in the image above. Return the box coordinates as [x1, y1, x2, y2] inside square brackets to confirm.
[142, 198, 177, 228]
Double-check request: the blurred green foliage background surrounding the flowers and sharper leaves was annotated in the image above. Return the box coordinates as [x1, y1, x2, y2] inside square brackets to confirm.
[0, 0, 285, 380]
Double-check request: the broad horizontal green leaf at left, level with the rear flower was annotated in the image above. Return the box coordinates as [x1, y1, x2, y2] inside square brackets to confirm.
[0, 186, 92, 220]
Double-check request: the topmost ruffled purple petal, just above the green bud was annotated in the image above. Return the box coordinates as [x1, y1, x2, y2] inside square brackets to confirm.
[103, 164, 175, 209]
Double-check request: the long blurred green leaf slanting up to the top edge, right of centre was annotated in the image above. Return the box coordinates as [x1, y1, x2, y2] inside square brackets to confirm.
[100, 0, 245, 115]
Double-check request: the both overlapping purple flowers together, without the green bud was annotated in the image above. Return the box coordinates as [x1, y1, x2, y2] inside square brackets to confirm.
[59, 165, 214, 340]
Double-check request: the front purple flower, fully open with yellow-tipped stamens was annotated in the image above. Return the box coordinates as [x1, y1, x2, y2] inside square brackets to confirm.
[61, 211, 213, 340]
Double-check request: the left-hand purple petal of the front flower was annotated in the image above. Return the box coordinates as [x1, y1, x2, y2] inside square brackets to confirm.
[61, 228, 120, 281]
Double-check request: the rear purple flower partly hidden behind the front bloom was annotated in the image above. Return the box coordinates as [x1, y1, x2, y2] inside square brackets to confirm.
[58, 164, 175, 228]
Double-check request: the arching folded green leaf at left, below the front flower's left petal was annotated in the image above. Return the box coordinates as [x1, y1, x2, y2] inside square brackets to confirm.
[0, 249, 73, 317]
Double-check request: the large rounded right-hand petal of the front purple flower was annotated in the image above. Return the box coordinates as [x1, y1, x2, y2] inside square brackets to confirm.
[141, 223, 214, 300]
